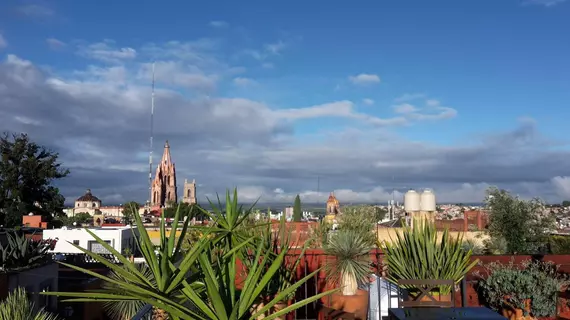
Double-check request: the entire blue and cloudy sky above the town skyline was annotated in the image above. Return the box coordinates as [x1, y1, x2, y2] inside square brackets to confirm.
[0, 0, 570, 205]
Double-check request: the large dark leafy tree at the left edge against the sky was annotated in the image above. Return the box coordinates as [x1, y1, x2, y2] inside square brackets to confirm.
[0, 133, 69, 227]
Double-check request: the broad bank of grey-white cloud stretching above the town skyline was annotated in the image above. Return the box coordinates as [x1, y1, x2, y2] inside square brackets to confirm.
[0, 39, 570, 204]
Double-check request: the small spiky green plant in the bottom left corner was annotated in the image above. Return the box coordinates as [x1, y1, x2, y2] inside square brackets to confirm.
[0, 287, 59, 320]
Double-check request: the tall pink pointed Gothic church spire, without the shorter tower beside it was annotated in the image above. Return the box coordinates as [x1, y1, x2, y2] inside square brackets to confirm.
[151, 140, 178, 208]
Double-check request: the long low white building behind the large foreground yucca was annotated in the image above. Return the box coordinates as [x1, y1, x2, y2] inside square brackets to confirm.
[43, 226, 138, 254]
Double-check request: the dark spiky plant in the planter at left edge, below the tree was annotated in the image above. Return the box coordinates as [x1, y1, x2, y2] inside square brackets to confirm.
[0, 232, 52, 272]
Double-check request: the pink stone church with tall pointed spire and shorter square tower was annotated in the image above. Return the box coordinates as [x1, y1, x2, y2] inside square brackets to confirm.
[150, 141, 196, 208]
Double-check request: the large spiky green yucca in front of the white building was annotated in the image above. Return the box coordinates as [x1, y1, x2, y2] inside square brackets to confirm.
[43, 201, 210, 319]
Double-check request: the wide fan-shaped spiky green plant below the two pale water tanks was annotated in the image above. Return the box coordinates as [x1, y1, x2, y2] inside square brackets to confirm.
[384, 219, 477, 294]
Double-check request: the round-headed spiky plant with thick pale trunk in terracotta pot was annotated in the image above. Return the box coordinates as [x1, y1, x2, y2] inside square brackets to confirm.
[325, 229, 371, 319]
